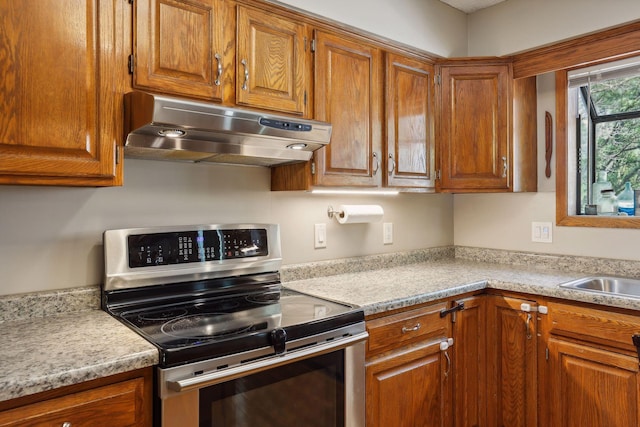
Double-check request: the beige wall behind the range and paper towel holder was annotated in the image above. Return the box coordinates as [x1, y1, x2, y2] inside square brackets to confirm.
[0, 159, 453, 295]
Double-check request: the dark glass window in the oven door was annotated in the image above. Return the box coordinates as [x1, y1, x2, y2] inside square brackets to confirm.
[200, 350, 345, 427]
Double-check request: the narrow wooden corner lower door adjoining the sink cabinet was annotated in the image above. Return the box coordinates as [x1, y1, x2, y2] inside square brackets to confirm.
[487, 296, 538, 427]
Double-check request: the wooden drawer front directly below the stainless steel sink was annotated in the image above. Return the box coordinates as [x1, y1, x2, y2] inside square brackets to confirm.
[548, 302, 640, 351]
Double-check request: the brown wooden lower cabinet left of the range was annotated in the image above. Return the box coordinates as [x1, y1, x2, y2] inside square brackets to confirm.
[0, 368, 153, 427]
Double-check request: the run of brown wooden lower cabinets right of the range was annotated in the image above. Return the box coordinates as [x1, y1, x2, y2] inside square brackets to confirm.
[366, 290, 640, 427]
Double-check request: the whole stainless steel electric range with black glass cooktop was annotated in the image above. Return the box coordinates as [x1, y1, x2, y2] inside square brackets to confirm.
[102, 224, 367, 427]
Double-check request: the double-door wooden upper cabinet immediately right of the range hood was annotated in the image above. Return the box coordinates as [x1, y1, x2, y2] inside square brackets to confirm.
[272, 37, 435, 191]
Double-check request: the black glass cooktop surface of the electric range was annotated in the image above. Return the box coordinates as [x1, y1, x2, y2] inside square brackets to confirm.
[109, 285, 364, 367]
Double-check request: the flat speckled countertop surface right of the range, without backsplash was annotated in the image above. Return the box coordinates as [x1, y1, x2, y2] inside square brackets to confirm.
[284, 260, 640, 315]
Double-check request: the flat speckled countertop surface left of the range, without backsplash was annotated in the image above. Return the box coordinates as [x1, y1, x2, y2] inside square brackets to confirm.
[0, 310, 158, 401]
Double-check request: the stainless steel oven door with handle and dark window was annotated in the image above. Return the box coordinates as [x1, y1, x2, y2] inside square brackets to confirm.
[159, 332, 367, 427]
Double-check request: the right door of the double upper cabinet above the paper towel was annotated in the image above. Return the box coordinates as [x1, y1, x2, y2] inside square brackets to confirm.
[385, 53, 435, 188]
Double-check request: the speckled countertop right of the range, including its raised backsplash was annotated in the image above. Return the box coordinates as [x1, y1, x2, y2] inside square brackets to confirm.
[282, 247, 640, 315]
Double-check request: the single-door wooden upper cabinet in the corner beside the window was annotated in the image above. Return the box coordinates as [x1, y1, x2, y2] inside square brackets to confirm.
[438, 60, 537, 192]
